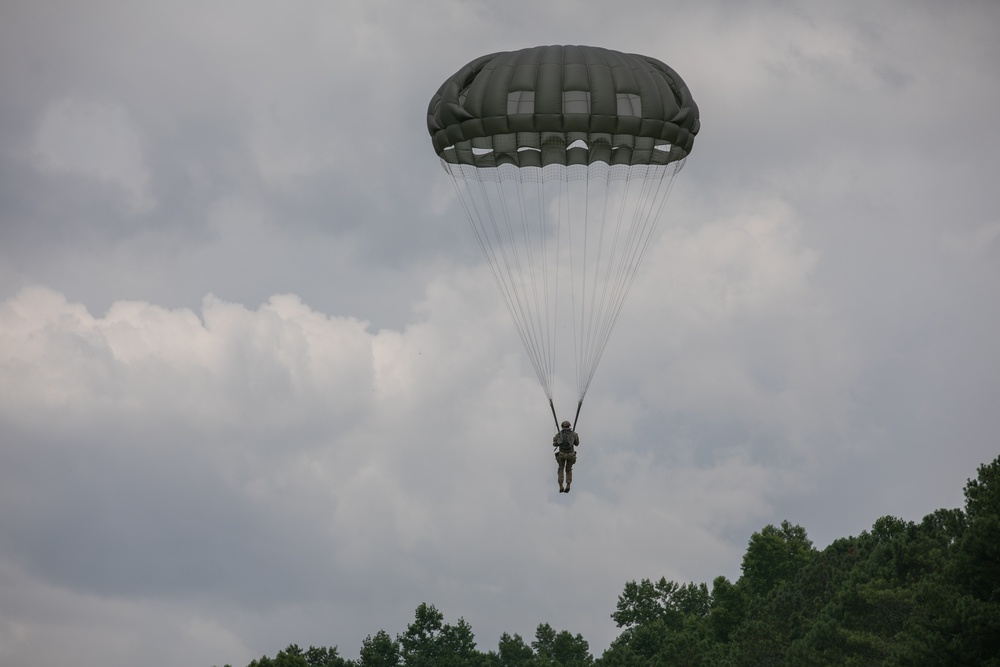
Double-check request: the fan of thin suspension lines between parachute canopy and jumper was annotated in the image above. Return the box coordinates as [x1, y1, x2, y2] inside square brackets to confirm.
[445, 154, 684, 422]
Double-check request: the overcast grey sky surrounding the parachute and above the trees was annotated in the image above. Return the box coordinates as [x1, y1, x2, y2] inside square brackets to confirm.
[0, 0, 1000, 667]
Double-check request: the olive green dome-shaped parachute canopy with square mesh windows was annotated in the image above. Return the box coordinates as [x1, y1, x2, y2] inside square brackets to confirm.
[427, 46, 699, 167]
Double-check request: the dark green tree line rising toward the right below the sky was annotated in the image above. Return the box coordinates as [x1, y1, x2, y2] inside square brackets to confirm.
[219, 457, 1000, 667]
